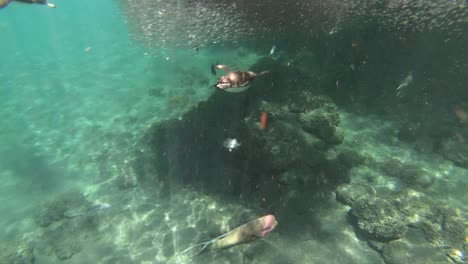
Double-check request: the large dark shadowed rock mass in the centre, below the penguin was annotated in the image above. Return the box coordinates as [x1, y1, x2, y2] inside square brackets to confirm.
[134, 57, 362, 210]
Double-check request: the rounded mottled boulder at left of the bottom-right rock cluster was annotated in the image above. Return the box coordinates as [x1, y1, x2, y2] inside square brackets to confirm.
[351, 196, 408, 241]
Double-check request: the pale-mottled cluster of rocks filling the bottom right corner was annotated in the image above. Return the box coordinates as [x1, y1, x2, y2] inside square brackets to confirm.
[336, 184, 466, 264]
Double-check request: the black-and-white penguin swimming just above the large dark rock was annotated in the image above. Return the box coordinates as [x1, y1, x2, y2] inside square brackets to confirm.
[211, 64, 269, 93]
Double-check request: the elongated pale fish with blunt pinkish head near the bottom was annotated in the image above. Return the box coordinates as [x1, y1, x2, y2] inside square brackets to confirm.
[176, 215, 278, 261]
